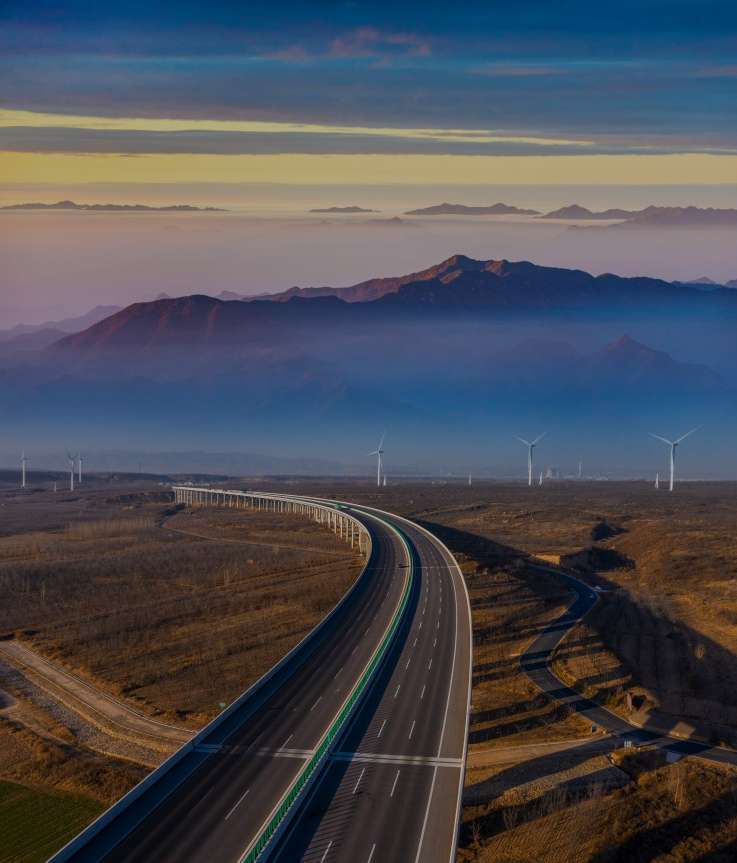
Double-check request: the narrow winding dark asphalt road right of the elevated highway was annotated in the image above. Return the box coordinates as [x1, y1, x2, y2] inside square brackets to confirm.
[520, 567, 737, 764]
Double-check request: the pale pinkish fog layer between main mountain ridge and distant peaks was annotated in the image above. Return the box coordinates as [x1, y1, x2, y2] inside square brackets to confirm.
[0, 208, 737, 328]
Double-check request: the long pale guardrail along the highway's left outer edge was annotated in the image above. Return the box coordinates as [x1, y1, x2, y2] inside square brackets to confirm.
[48, 486, 372, 863]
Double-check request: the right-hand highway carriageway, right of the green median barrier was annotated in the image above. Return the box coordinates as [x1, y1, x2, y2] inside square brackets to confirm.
[272, 502, 471, 863]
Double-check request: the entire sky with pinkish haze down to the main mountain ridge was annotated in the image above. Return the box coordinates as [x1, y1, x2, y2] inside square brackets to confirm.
[0, 0, 737, 476]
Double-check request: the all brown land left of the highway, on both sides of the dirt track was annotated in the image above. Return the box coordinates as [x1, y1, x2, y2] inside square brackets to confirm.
[0, 483, 361, 859]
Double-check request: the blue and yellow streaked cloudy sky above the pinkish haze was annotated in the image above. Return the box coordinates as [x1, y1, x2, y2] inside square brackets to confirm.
[0, 0, 737, 190]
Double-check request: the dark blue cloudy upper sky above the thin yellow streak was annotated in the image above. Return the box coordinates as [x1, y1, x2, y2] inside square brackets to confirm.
[0, 0, 737, 147]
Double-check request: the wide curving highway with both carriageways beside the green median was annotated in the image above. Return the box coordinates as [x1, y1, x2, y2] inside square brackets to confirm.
[52, 502, 471, 863]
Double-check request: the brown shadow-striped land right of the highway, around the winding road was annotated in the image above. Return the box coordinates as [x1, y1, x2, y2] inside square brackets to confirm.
[252, 482, 737, 863]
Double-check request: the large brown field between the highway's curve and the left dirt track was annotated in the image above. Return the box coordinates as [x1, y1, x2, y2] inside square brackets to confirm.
[0, 496, 360, 726]
